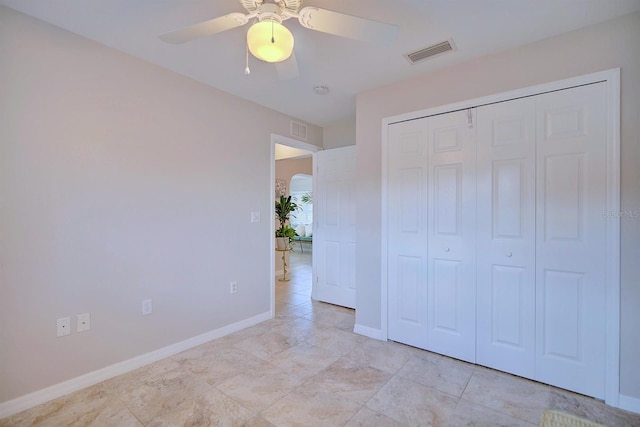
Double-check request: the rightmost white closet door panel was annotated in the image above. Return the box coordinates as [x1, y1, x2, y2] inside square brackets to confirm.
[535, 83, 607, 398]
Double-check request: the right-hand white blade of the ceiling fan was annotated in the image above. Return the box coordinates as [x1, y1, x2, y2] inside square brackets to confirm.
[298, 7, 398, 43]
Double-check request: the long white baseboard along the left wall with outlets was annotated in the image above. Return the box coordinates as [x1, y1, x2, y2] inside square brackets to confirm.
[0, 311, 273, 419]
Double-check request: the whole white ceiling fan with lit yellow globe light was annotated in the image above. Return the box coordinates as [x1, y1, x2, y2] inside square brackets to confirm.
[158, 0, 398, 80]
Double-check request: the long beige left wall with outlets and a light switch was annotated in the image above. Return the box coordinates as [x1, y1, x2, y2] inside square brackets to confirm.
[0, 6, 322, 403]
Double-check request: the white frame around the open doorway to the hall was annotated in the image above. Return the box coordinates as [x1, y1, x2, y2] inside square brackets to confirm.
[269, 133, 322, 318]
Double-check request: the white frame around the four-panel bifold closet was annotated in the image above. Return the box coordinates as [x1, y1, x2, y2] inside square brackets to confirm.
[376, 68, 620, 407]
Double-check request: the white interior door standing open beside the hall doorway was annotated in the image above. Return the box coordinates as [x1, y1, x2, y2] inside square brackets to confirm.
[313, 146, 356, 308]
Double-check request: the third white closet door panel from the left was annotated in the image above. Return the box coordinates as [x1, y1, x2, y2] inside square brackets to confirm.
[477, 98, 535, 378]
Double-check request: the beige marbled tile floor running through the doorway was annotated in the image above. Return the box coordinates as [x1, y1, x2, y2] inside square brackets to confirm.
[0, 249, 640, 427]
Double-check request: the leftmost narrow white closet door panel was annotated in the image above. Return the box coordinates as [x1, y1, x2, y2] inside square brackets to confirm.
[387, 119, 428, 348]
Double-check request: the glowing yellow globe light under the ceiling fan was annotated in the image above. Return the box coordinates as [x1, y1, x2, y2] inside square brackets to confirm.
[247, 19, 293, 62]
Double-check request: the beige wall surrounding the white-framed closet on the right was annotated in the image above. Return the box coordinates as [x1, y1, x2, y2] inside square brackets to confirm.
[356, 13, 640, 399]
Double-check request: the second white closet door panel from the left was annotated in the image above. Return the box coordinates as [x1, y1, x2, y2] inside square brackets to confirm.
[427, 110, 476, 362]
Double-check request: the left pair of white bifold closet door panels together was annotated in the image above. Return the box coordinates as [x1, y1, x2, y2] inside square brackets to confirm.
[387, 111, 476, 362]
